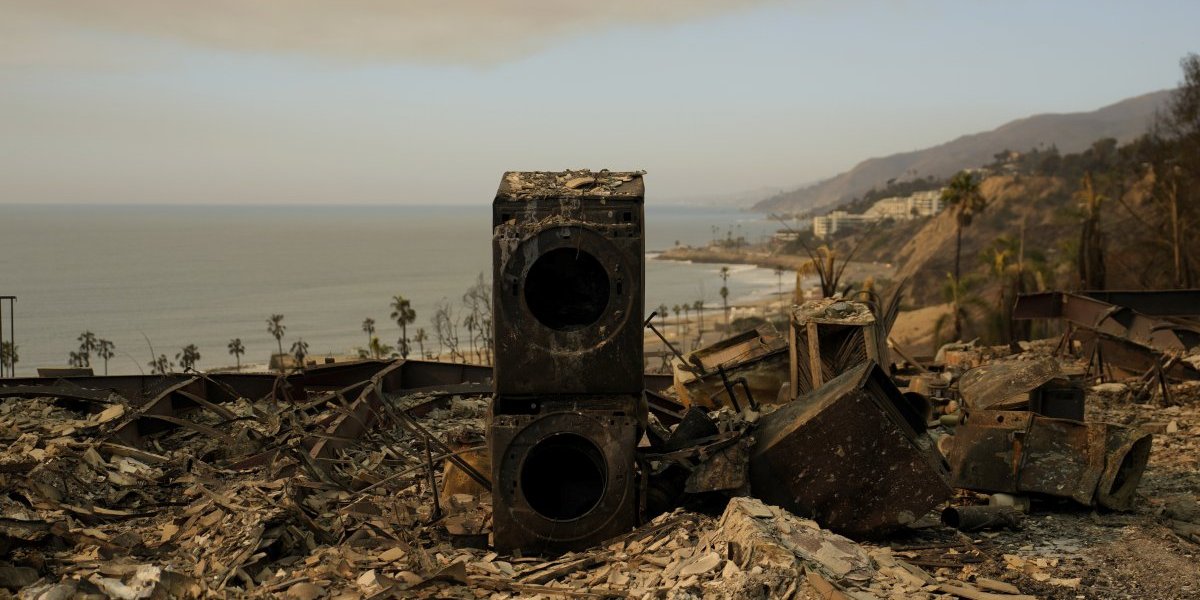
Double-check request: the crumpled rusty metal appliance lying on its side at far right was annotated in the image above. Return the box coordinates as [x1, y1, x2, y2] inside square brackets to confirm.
[947, 410, 1151, 510]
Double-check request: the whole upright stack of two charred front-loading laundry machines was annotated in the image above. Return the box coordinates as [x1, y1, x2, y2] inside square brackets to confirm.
[488, 170, 647, 553]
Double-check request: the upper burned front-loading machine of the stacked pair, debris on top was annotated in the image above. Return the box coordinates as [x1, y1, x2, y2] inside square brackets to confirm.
[492, 170, 646, 395]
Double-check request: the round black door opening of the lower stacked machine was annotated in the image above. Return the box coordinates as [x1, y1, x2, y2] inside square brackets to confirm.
[520, 433, 608, 521]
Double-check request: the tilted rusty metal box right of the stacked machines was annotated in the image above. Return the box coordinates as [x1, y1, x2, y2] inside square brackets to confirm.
[750, 361, 952, 538]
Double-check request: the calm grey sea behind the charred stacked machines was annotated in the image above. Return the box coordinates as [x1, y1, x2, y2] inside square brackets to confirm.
[0, 205, 776, 376]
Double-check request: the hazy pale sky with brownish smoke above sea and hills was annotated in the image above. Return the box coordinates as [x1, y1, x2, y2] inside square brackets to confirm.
[0, 0, 1200, 205]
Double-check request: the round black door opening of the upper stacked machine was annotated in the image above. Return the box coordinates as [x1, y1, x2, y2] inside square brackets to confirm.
[523, 247, 610, 331]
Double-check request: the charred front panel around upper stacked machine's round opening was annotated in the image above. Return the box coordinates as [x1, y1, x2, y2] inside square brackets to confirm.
[496, 224, 644, 395]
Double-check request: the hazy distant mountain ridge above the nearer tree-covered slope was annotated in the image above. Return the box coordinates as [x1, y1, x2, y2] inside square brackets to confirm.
[754, 91, 1170, 212]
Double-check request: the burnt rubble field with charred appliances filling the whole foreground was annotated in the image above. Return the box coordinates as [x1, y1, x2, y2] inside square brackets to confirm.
[0, 172, 1200, 600]
